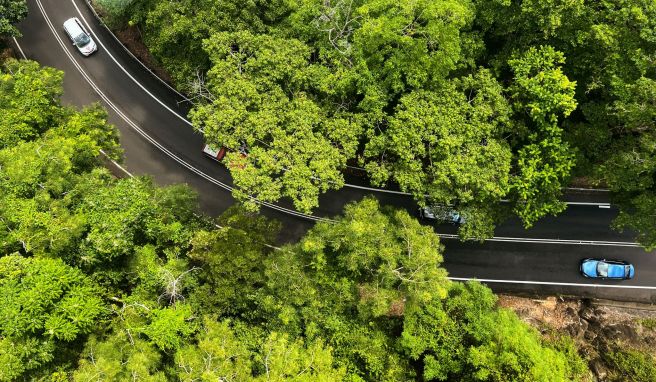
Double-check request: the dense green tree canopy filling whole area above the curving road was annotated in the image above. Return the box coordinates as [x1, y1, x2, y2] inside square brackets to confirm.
[104, 0, 656, 248]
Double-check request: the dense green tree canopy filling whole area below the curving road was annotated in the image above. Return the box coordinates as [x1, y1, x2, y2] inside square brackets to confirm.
[0, 61, 587, 382]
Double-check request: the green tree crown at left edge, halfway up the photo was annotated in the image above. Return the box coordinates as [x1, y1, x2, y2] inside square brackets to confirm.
[0, 138, 97, 255]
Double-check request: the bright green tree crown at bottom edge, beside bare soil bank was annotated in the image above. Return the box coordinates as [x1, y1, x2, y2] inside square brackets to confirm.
[401, 282, 581, 381]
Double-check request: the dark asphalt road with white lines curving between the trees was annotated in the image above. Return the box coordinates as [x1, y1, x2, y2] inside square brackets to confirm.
[18, 0, 656, 303]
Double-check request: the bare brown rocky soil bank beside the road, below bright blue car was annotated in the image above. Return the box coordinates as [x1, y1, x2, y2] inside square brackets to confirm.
[498, 295, 656, 381]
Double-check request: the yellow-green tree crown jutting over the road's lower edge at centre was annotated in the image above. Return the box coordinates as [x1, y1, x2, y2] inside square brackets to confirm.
[299, 198, 446, 308]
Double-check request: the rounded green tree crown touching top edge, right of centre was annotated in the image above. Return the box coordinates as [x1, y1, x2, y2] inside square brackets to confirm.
[353, 0, 474, 98]
